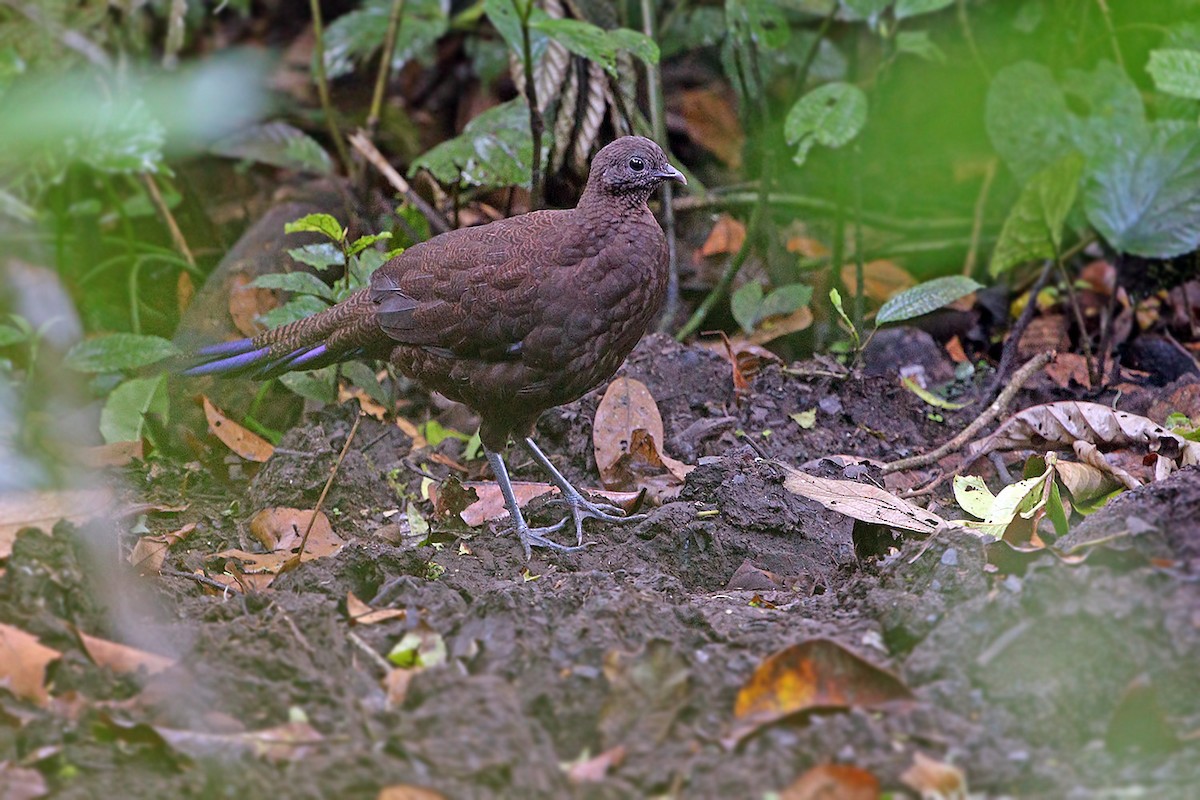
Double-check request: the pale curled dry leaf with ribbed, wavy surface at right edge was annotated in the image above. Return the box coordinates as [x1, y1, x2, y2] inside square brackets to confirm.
[968, 401, 1200, 469]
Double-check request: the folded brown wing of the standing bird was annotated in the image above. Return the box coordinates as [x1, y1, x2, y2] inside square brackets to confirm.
[371, 211, 594, 361]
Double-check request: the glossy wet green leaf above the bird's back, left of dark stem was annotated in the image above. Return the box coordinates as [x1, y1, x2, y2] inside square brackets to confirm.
[409, 98, 533, 186]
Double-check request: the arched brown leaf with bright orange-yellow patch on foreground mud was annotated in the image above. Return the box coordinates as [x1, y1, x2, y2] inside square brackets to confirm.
[732, 639, 912, 742]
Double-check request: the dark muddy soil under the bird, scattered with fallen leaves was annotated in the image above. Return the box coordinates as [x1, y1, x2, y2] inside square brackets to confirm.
[0, 337, 1200, 799]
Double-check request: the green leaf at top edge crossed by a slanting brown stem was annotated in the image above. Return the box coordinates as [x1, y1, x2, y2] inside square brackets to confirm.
[325, 0, 449, 78]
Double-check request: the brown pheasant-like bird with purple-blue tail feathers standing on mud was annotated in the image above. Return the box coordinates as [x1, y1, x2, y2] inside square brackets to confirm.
[192, 137, 686, 558]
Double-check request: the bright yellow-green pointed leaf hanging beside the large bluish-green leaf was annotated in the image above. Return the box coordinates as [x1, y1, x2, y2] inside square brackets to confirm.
[990, 154, 1084, 276]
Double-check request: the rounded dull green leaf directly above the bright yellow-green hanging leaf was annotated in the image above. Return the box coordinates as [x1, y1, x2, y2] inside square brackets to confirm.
[985, 61, 1073, 181]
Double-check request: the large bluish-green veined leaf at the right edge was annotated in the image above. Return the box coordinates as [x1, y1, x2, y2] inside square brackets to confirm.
[1084, 122, 1200, 258]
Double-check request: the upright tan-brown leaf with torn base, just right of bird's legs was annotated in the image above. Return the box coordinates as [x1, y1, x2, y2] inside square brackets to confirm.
[592, 378, 694, 497]
